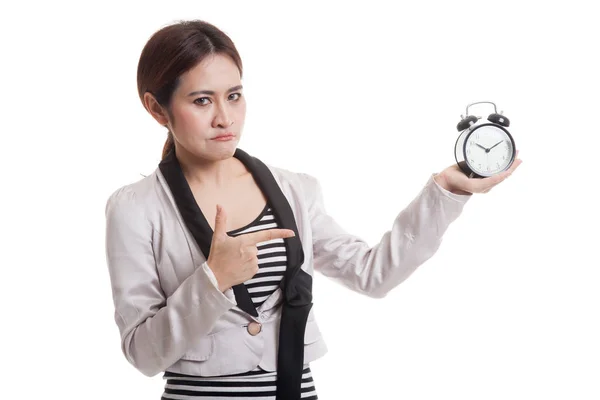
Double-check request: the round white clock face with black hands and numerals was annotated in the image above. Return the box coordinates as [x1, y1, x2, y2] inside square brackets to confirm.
[465, 125, 514, 176]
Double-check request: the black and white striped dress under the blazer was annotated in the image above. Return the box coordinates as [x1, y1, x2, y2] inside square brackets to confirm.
[161, 203, 318, 400]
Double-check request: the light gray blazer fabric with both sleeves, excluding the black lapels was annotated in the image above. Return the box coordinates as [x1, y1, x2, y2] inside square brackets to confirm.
[106, 164, 470, 376]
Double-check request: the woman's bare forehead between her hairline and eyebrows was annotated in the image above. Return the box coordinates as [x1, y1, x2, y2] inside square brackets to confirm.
[180, 54, 240, 94]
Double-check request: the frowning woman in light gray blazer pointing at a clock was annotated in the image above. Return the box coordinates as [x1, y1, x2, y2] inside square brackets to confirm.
[106, 21, 520, 399]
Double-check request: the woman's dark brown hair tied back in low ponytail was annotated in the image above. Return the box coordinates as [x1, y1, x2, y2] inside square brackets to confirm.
[137, 20, 242, 159]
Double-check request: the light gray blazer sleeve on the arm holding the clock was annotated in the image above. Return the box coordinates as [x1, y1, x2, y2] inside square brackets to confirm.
[301, 173, 471, 298]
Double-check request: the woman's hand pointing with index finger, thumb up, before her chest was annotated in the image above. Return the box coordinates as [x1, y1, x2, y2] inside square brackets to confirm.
[206, 204, 296, 292]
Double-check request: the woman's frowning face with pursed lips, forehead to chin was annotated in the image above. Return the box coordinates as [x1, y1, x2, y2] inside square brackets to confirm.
[169, 54, 246, 160]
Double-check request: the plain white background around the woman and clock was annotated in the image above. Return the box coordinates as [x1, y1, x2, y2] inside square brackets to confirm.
[0, 1, 600, 400]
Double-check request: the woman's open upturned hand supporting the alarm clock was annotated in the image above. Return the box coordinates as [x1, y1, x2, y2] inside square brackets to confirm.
[434, 150, 523, 195]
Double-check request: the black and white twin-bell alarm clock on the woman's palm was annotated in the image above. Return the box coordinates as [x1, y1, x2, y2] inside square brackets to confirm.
[454, 101, 516, 178]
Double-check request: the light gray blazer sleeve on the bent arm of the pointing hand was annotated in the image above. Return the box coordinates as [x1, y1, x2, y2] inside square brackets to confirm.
[105, 187, 235, 376]
